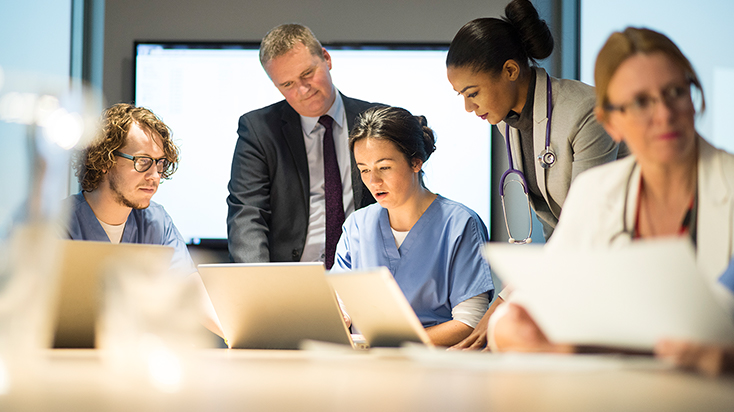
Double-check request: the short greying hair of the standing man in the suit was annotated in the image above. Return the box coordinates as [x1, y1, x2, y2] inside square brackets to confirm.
[260, 23, 324, 67]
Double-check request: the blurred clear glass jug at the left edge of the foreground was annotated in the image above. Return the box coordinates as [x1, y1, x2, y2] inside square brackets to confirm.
[0, 67, 101, 394]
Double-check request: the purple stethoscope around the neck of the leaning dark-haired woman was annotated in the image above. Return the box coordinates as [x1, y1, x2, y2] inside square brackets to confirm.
[500, 73, 556, 245]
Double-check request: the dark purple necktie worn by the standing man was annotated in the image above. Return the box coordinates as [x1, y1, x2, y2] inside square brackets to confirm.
[319, 115, 344, 269]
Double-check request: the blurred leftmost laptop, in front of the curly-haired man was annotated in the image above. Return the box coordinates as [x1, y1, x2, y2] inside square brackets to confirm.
[53, 240, 174, 348]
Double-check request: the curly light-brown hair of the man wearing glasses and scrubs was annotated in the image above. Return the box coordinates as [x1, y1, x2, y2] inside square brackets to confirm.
[72, 103, 179, 192]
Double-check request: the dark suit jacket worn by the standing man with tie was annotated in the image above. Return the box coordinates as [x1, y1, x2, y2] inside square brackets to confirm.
[227, 95, 376, 262]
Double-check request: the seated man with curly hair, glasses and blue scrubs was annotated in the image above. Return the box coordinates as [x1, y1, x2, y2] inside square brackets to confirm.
[64, 103, 222, 336]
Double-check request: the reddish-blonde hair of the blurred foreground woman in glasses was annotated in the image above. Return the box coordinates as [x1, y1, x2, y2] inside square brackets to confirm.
[594, 27, 706, 112]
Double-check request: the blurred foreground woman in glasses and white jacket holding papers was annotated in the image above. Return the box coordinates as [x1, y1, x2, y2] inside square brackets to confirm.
[492, 28, 734, 373]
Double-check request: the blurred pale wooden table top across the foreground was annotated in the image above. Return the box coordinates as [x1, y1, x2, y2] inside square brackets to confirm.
[0, 347, 734, 412]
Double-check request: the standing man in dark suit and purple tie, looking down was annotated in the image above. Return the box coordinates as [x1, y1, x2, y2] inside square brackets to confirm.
[227, 24, 375, 268]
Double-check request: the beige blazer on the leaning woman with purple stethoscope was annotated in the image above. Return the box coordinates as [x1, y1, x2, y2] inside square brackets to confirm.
[497, 68, 618, 239]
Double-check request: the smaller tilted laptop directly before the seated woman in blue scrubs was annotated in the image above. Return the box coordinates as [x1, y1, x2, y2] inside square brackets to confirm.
[327, 267, 433, 347]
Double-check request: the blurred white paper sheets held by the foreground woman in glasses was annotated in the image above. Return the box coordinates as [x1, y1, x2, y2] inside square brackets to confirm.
[484, 239, 734, 352]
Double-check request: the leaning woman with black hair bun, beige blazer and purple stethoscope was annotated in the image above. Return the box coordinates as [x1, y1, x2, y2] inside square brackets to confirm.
[446, 0, 618, 349]
